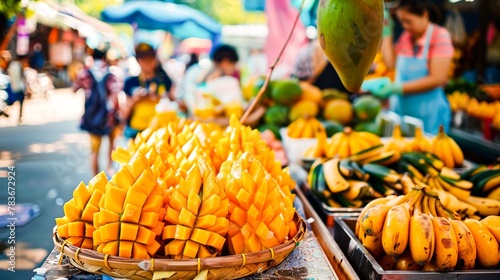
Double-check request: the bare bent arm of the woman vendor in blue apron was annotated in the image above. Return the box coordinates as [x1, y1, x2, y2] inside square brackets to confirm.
[403, 57, 451, 95]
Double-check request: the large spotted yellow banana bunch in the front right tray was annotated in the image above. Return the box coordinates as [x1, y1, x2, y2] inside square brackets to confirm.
[355, 182, 500, 271]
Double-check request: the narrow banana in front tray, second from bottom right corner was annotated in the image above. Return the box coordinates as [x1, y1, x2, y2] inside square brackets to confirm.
[450, 220, 476, 270]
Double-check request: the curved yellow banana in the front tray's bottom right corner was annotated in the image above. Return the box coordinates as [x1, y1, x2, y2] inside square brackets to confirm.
[464, 219, 498, 268]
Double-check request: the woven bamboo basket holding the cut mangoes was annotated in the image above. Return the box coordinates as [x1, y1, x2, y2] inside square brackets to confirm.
[53, 213, 306, 280]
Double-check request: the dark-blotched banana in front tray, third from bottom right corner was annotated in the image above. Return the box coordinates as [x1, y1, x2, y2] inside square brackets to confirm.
[432, 217, 458, 271]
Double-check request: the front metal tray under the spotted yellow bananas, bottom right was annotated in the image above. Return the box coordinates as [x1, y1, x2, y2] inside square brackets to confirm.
[330, 216, 500, 280]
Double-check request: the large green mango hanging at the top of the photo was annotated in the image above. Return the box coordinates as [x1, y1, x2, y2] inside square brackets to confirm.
[318, 0, 384, 93]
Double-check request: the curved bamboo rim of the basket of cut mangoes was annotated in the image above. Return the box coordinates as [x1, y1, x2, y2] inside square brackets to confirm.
[52, 212, 307, 272]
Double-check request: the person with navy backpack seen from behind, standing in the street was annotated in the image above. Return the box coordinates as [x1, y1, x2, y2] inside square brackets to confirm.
[73, 46, 121, 176]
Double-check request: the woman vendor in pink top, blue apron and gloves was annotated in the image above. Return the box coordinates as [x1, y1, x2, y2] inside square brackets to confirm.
[372, 0, 454, 134]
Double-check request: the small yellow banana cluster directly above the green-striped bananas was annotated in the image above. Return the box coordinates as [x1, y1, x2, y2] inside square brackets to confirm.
[347, 144, 401, 165]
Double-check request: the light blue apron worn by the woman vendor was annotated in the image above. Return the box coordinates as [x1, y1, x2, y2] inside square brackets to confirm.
[390, 25, 451, 135]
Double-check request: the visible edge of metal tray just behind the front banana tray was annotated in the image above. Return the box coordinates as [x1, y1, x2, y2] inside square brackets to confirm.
[301, 184, 363, 227]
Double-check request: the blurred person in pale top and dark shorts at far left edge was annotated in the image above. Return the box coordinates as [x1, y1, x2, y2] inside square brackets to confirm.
[7, 56, 28, 124]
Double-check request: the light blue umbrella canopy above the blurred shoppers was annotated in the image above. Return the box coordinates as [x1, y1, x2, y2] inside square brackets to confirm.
[101, 1, 221, 41]
